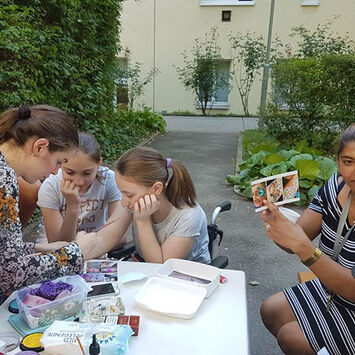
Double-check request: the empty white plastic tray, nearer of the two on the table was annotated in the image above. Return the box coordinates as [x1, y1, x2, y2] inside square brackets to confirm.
[135, 276, 207, 319]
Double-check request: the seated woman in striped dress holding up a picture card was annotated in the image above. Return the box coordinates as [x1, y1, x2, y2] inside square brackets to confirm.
[261, 125, 355, 355]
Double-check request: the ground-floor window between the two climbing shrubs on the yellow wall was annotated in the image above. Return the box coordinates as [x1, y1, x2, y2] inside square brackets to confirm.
[197, 60, 230, 110]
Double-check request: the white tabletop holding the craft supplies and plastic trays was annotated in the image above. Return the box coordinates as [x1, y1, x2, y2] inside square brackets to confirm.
[0, 262, 249, 355]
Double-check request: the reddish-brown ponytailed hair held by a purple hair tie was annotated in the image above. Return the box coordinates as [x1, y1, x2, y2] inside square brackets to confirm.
[115, 147, 196, 208]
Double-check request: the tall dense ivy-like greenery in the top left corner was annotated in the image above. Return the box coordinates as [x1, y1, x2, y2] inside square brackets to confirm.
[0, 0, 122, 125]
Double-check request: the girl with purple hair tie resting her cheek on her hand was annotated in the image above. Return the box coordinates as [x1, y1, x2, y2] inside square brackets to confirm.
[116, 147, 210, 263]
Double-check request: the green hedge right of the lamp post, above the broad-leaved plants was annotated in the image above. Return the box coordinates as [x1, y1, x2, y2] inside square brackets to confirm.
[265, 55, 355, 152]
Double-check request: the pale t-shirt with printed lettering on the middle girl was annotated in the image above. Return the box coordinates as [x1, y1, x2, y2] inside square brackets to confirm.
[37, 166, 121, 242]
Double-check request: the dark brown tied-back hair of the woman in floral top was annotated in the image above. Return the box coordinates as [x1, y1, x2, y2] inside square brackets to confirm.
[0, 105, 78, 152]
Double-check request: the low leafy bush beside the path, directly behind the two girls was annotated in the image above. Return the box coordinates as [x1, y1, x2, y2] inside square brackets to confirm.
[82, 108, 166, 163]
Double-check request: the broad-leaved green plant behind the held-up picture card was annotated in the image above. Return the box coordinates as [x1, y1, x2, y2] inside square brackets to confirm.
[226, 141, 337, 204]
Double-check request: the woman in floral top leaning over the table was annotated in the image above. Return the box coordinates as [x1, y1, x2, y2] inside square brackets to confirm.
[0, 105, 101, 304]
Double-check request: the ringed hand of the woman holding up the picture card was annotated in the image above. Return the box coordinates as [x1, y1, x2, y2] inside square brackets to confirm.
[260, 200, 311, 254]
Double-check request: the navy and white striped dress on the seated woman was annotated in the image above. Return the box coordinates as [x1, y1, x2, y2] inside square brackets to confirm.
[284, 174, 355, 355]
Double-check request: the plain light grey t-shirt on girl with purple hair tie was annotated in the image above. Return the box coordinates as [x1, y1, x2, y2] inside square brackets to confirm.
[132, 204, 211, 263]
